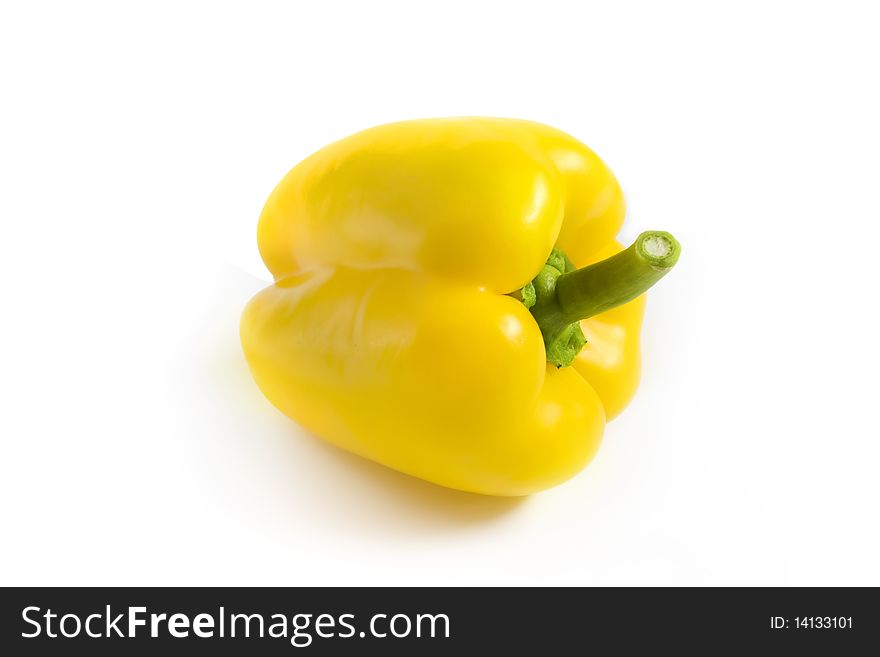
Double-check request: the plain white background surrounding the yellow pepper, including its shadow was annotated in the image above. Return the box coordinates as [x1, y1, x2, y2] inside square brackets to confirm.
[0, 0, 880, 585]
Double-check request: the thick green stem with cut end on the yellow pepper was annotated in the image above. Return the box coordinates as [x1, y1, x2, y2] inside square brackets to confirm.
[524, 230, 681, 367]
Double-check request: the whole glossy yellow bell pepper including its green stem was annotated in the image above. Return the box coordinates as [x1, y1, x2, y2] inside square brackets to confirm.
[241, 118, 679, 495]
